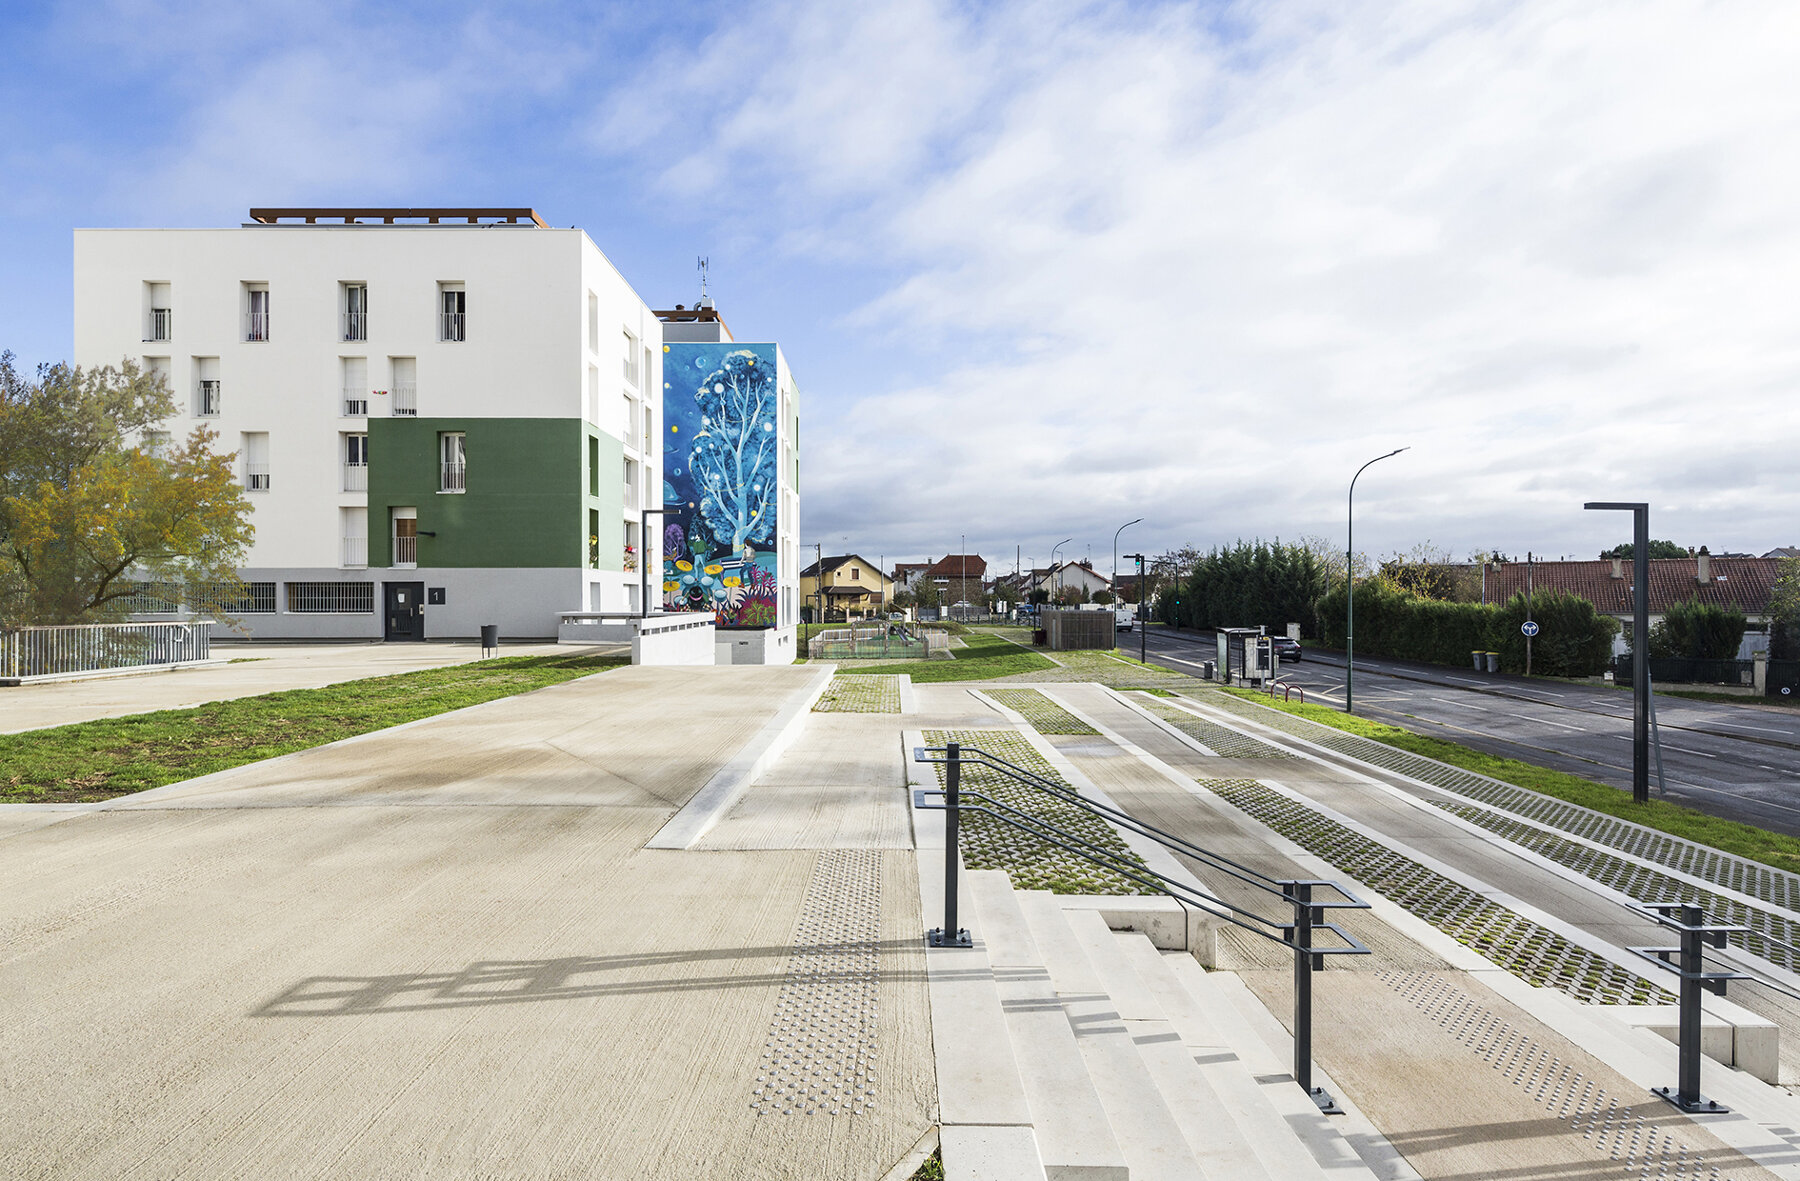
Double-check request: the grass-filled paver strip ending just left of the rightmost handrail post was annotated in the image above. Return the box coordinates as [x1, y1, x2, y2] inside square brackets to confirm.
[1199, 780, 1674, 1005]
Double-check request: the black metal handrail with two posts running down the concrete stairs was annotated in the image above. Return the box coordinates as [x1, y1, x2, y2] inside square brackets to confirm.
[913, 742, 1370, 1114]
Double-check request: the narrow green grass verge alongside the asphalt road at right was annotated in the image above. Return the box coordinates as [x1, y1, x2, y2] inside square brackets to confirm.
[1219, 688, 1800, 873]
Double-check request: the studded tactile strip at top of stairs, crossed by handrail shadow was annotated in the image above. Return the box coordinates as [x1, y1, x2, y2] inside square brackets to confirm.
[751, 850, 882, 1116]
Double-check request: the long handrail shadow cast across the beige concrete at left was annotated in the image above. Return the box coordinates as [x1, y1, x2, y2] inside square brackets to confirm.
[248, 940, 925, 1017]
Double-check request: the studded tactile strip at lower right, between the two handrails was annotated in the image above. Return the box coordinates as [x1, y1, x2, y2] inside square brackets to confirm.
[1377, 972, 1723, 1181]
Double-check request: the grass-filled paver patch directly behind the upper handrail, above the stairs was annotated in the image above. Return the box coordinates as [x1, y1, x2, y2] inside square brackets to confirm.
[925, 729, 1157, 895]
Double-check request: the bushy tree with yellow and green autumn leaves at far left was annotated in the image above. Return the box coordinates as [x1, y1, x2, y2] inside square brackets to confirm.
[0, 353, 252, 625]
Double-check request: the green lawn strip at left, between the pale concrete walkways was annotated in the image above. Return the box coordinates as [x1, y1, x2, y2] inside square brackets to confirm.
[0, 654, 630, 803]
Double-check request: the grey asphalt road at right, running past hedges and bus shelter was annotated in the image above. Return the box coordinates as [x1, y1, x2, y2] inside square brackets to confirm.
[1120, 628, 1800, 837]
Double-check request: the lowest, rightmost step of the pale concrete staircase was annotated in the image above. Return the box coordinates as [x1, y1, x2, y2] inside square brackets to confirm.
[1170, 960, 1375, 1181]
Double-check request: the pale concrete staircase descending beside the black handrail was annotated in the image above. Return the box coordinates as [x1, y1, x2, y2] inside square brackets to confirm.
[922, 867, 1389, 1181]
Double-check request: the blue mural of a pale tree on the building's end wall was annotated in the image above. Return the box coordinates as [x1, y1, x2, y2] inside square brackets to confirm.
[662, 344, 779, 628]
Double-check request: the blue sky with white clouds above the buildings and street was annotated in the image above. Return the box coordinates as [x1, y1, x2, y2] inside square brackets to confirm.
[0, 0, 1800, 569]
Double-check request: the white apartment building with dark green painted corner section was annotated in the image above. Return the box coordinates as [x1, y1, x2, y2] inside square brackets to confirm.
[74, 209, 669, 639]
